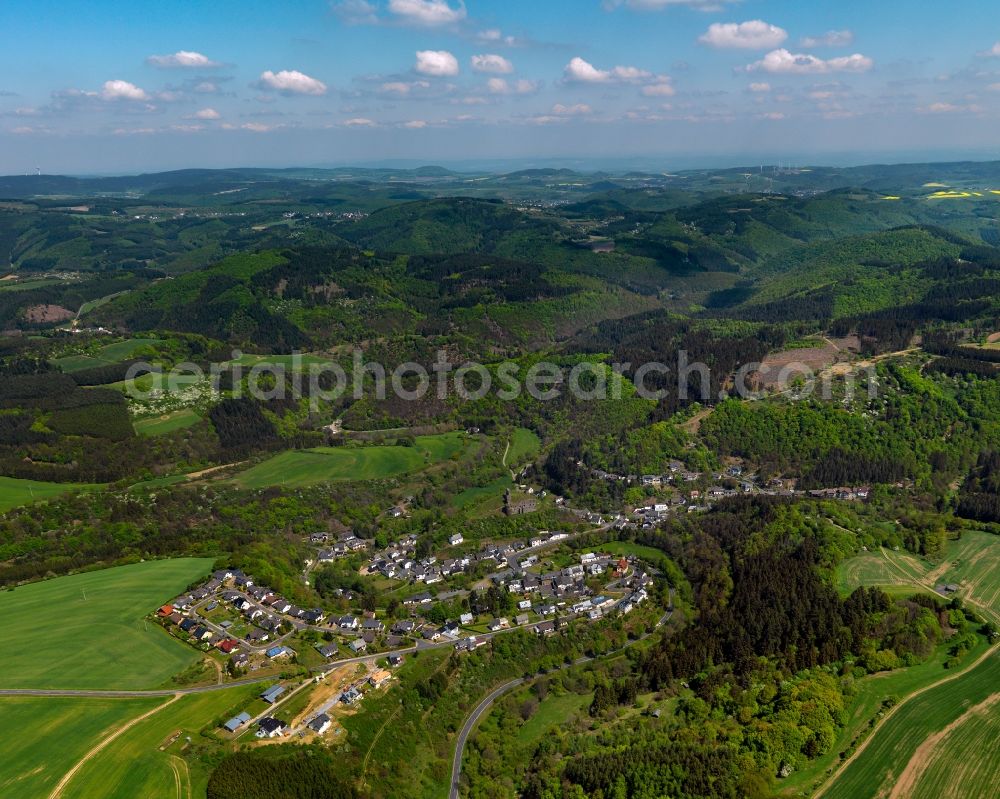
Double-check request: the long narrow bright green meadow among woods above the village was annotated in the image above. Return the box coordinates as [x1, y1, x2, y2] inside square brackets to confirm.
[233, 433, 469, 488]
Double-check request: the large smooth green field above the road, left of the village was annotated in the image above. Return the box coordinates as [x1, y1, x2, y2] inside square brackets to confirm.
[0, 558, 212, 689]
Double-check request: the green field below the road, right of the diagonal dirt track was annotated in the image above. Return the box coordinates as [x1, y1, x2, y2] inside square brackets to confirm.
[61, 686, 260, 799]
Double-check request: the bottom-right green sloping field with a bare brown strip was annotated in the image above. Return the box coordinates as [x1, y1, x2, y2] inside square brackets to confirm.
[822, 649, 1000, 799]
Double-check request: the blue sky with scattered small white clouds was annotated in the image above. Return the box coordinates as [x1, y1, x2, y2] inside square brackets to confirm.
[0, 0, 1000, 173]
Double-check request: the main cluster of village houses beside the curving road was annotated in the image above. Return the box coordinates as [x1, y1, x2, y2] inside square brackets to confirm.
[154, 532, 654, 741]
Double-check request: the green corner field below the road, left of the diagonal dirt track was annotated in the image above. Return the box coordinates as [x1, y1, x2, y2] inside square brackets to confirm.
[0, 696, 158, 799]
